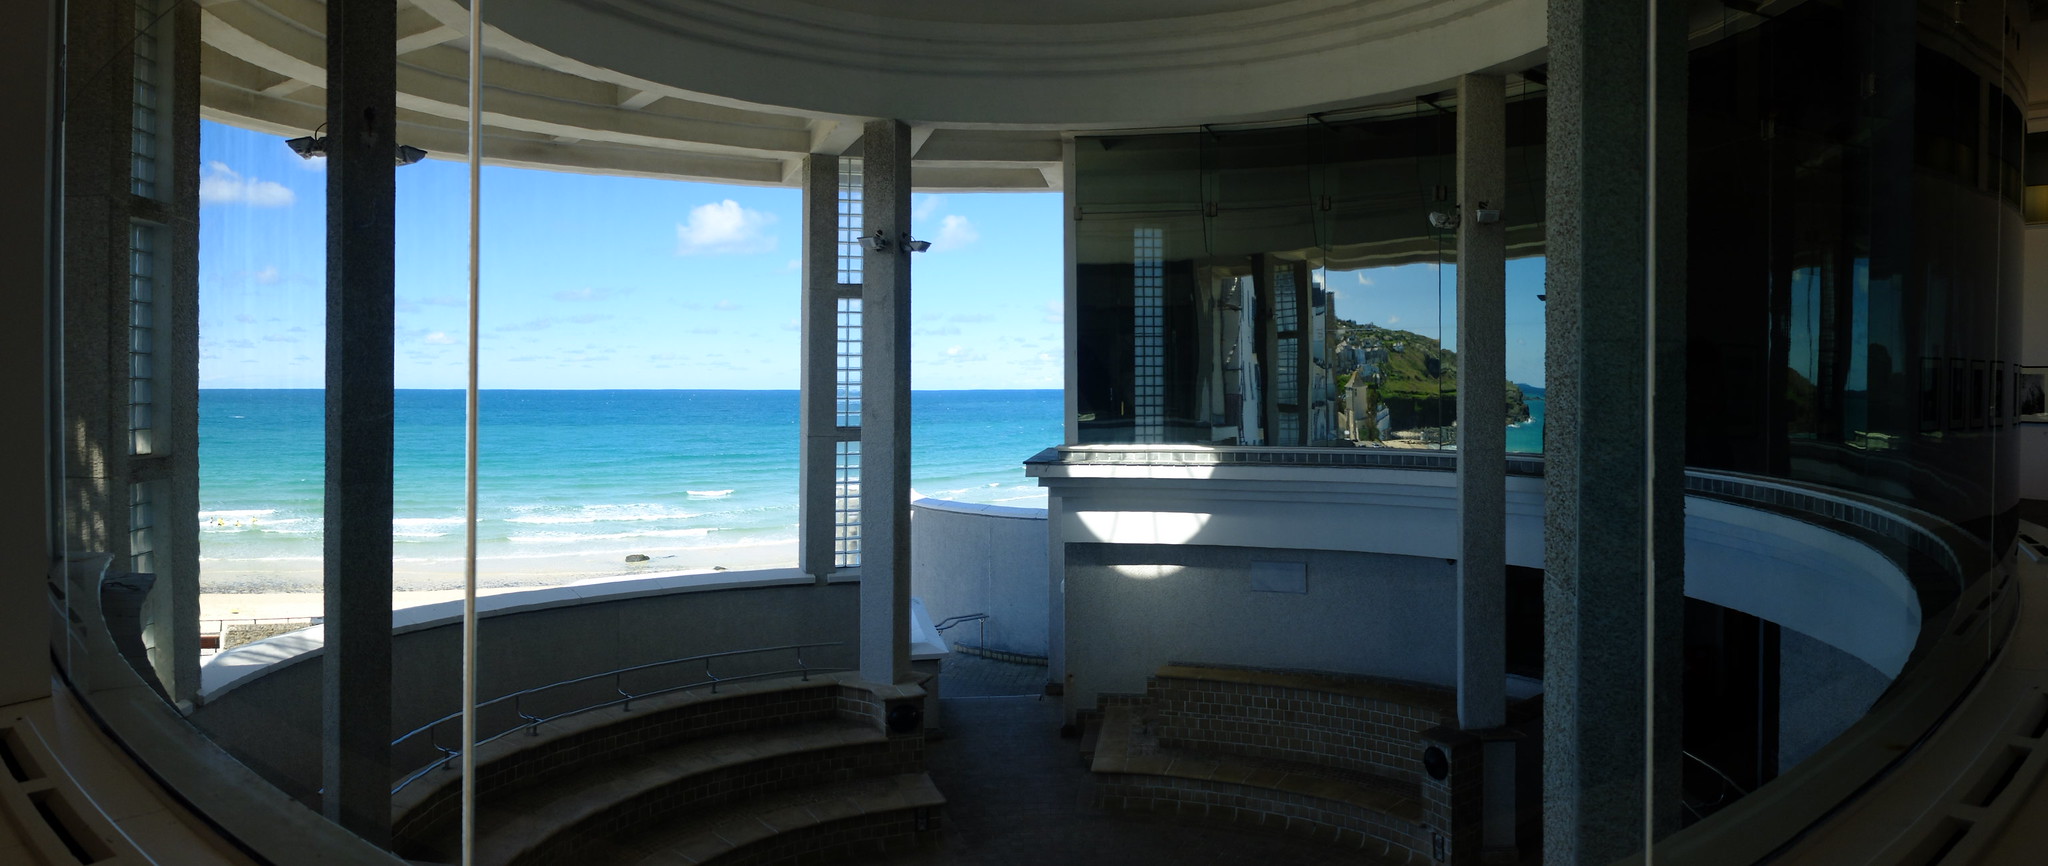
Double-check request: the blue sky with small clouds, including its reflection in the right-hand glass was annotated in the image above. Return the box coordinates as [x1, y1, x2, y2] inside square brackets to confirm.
[199, 123, 1542, 389]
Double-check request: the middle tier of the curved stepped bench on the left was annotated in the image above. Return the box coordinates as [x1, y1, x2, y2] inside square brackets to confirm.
[399, 721, 897, 864]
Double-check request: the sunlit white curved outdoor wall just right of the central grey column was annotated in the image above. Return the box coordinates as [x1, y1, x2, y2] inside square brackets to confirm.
[909, 500, 1049, 655]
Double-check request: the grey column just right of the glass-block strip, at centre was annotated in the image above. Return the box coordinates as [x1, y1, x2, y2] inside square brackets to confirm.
[860, 121, 909, 682]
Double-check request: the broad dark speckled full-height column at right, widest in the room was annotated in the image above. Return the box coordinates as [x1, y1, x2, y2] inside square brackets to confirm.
[1544, 0, 1686, 864]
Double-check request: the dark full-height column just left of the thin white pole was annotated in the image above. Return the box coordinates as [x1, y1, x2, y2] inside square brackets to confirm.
[319, 0, 397, 846]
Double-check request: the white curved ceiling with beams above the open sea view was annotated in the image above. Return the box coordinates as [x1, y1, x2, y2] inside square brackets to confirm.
[201, 0, 1544, 190]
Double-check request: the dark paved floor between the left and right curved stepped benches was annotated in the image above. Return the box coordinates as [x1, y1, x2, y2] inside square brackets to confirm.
[868, 655, 1405, 866]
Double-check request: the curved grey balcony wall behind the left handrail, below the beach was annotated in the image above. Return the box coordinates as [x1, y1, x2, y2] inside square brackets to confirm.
[190, 569, 858, 807]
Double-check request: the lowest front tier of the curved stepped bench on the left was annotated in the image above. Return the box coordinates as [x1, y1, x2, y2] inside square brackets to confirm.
[565, 772, 946, 866]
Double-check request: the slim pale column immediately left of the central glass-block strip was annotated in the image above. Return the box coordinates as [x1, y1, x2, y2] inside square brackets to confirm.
[797, 154, 840, 581]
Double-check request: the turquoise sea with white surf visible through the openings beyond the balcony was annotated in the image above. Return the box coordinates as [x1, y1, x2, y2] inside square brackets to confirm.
[199, 389, 1061, 590]
